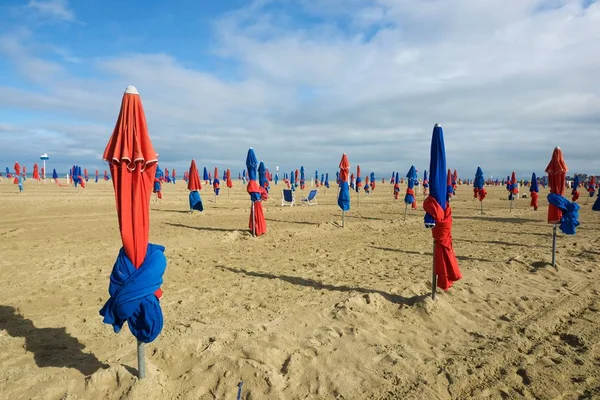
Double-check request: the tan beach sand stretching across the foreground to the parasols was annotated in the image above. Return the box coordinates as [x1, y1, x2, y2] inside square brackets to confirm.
[0, 179, 600, 400]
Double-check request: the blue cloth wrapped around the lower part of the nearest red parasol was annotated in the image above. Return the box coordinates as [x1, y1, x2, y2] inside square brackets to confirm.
[100, 244, 167, 343]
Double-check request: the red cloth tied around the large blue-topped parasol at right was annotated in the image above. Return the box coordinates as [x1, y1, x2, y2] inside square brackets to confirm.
[423, 196, 462, 290]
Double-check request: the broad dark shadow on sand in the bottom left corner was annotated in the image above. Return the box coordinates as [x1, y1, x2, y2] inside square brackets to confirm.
[0, 306, 108, 376]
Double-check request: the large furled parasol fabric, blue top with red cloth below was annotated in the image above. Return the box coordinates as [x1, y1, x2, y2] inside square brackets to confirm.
[423, 124, 462, 290]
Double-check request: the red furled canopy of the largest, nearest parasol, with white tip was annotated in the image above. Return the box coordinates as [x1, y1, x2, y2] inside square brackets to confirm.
[102, 86, 162, 282]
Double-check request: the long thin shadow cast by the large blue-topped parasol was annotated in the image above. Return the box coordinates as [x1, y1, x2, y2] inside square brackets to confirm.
[218, 265, 431, 306]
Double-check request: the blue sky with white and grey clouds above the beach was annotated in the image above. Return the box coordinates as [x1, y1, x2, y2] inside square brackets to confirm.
[0, 0, 600, 178]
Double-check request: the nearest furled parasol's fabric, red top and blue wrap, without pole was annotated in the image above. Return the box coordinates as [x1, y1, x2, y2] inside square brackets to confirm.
[100, 86, 167, 343]
